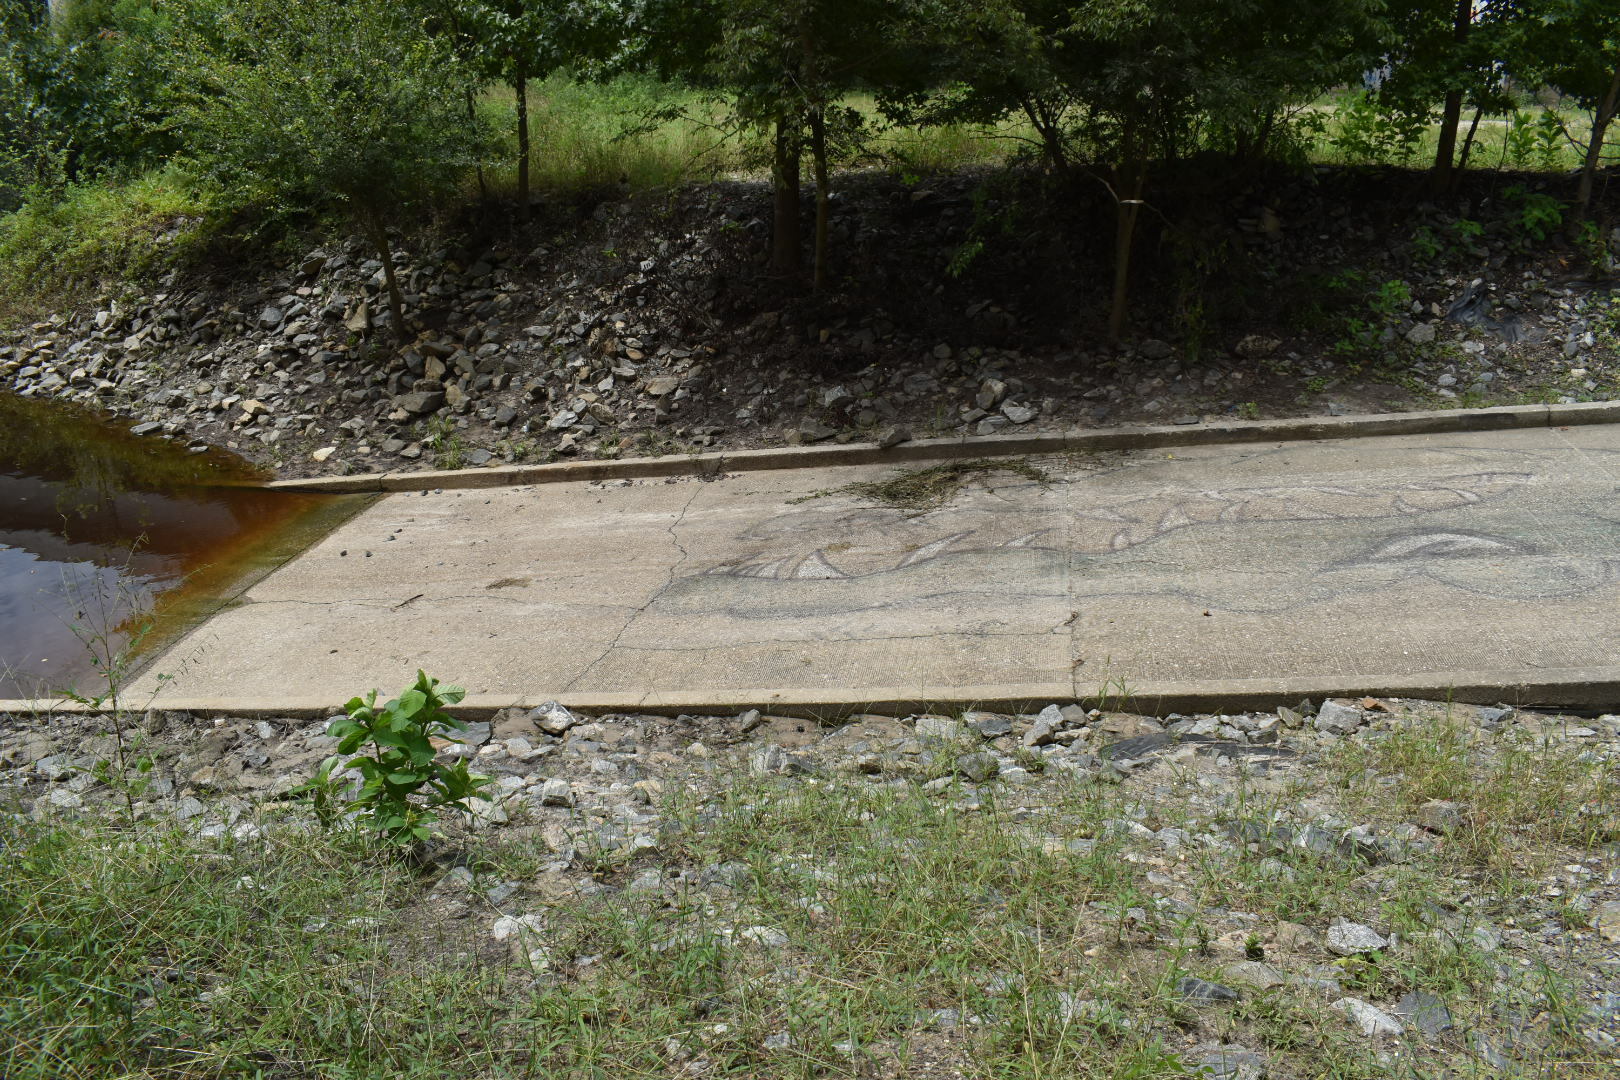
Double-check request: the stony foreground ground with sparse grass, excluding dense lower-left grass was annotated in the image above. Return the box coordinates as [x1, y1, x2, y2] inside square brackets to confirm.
[0, 699, 1620, 1078]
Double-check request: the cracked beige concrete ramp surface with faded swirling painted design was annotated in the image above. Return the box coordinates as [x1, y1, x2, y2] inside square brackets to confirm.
[123, 426, 1620, 708]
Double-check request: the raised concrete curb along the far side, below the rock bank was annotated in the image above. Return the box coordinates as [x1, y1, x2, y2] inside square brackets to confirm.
[264, 402, 1620, 494]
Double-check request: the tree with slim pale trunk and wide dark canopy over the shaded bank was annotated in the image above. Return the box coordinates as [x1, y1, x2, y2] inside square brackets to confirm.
[910, 0, 1383, 340]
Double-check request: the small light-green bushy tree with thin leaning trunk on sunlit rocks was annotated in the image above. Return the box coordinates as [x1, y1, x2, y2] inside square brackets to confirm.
[175, 0, 488, 342]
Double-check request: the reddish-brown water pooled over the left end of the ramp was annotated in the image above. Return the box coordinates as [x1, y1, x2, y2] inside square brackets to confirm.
[0, 395, 361, 698]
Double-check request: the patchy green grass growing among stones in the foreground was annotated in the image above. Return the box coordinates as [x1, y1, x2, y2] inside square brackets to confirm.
[0, 696, 1615, 1080]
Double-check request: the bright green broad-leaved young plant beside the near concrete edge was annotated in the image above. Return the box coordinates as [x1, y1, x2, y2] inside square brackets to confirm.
[293, 670, 489, 847]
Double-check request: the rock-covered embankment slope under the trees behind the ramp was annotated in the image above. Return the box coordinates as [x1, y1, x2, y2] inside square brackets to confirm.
[0, 176, 1620, 474]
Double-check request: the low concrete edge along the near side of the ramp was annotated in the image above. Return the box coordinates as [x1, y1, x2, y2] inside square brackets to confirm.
[0, 667, 1620, 719]
